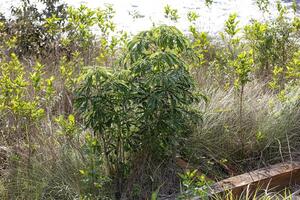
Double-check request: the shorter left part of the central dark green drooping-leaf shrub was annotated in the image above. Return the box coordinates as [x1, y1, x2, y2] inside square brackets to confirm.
[75, 68, 133, 198]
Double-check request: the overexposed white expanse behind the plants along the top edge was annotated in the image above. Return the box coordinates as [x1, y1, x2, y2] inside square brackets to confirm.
[0, 0, 296, 33]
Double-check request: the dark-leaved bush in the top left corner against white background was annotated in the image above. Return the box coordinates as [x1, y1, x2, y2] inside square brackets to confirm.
[8, 0, 66, 55]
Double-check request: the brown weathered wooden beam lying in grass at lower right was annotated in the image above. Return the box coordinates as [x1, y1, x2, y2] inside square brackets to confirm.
[210, 162, 300, 196]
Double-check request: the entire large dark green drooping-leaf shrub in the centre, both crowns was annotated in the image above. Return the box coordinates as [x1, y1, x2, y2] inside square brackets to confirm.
[76, 26, 204, 198]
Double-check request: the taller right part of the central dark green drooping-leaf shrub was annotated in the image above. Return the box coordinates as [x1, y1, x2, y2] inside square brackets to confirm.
[123, 26, 203, 155]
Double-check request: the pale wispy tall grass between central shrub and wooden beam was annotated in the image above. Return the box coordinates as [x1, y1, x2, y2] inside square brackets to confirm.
[185, 81, 300, 178]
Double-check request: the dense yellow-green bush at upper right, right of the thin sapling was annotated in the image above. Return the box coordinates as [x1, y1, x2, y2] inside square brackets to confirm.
[245, 6, 298, 86]
